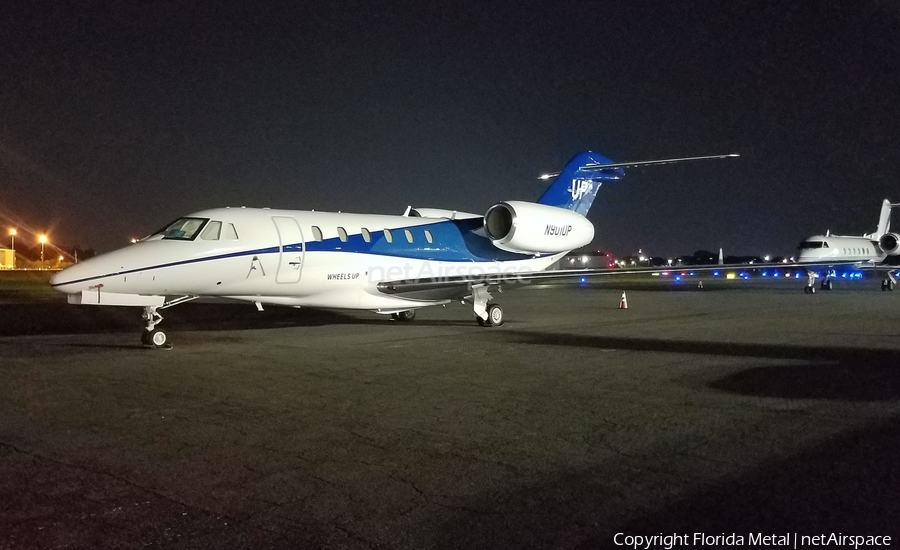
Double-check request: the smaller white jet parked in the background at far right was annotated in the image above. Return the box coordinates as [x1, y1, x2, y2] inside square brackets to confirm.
[797, 199, 900, 293]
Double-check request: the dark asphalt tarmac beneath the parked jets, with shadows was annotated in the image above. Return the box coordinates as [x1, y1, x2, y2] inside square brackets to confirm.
[0, 281, 900, 549]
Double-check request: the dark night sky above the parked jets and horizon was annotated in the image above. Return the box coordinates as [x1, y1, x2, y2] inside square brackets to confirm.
[0, 0, 900, 256]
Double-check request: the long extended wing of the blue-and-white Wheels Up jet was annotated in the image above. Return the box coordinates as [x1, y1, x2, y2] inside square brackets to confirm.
[377, 262, 859, 300]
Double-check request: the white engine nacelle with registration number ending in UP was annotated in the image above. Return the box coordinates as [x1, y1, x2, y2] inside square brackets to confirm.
[484, 201, 594, 254]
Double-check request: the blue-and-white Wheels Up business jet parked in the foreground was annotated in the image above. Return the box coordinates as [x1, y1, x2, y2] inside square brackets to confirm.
[51, 152, 738, 347]
